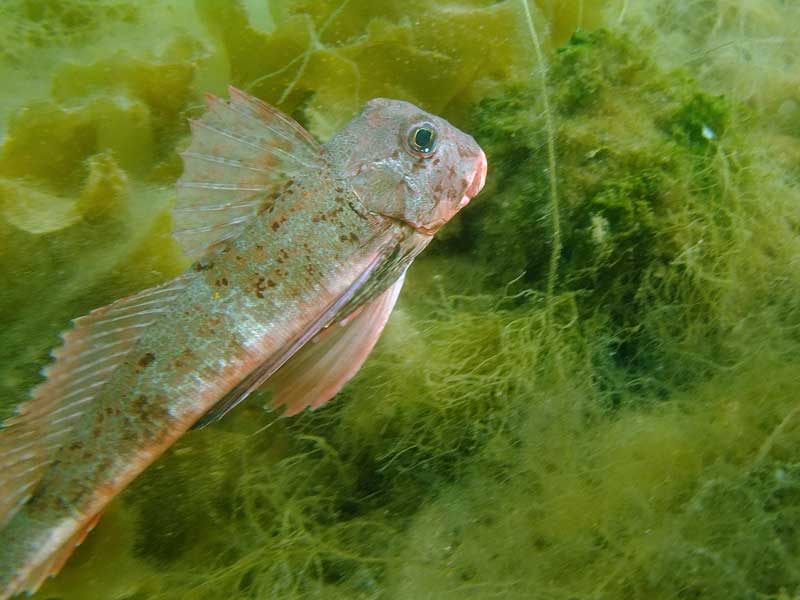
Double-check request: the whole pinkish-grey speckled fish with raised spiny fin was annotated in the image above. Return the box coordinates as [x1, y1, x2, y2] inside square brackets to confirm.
[0, 87, 487, 599]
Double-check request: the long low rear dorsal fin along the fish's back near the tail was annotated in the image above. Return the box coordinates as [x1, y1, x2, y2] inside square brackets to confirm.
[0, 276, 187, 527]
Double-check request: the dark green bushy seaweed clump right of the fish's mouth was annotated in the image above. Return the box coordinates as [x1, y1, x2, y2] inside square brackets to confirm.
[450, 30, 748, 400]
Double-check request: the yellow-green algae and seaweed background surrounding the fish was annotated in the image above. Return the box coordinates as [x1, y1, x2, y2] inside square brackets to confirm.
[0, 0, 800, 600]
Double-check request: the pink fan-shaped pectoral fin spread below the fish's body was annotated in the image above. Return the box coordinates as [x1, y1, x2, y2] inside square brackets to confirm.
[267, 276, 405, 416]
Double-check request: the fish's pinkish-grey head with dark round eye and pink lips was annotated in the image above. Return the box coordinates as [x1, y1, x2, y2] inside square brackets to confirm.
[329, 98, 486, 235]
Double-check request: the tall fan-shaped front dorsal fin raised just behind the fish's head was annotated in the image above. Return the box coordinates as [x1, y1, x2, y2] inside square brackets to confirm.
[173, 87, 323, 258]
